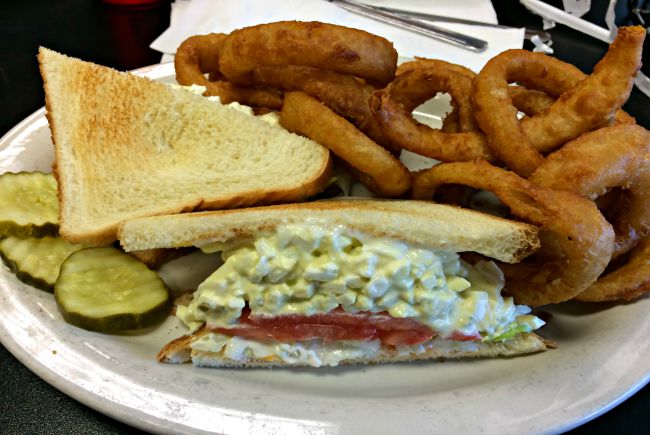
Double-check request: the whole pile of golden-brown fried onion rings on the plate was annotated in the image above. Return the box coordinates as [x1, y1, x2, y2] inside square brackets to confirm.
[175, 21, 650, 306]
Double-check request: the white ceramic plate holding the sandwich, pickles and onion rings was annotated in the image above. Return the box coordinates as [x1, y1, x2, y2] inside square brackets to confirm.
[0, 64, 650, 434]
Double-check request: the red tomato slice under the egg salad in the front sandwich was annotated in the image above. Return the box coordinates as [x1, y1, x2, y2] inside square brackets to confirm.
[214, 307, 481, 346]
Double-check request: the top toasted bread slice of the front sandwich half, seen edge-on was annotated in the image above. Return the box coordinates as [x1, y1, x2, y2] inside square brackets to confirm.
[118, 199, 539, 263]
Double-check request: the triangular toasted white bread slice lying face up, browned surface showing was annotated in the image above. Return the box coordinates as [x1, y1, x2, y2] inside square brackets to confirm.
[38, 48, 331, 243]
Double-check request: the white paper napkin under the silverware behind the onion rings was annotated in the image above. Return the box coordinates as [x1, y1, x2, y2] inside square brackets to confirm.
[151, 0, 524, 71]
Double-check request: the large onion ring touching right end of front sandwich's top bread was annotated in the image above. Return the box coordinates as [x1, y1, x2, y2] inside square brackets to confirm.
[412, 161, 614, 306]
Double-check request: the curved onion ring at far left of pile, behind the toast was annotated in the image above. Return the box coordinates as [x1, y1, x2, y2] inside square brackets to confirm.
[174, 33, 282, 109]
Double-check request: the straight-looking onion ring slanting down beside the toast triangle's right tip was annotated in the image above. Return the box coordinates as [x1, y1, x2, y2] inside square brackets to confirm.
[280, 92, 411, 197]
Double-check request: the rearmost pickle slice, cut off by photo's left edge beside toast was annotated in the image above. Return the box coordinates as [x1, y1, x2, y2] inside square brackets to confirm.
[0, 172, 59, 239]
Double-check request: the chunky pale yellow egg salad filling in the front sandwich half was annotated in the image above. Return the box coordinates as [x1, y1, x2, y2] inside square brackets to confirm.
[176, 221, 544, 350]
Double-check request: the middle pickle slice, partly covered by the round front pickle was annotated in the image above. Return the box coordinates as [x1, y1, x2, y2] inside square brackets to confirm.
[0, 237, 87, 292]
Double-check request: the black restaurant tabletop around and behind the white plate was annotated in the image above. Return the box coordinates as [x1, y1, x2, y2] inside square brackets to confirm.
[0, 0, 650, 434]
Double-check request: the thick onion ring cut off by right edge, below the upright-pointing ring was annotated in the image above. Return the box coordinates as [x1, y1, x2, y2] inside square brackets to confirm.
[529, 124, 650, 257]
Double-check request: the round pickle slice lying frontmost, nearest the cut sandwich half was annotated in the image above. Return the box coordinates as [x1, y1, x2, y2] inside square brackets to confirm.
[54, 247, 170, 332]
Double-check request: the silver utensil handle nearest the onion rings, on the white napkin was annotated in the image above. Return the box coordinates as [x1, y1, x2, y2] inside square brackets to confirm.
[329, 0, 487, 52]
